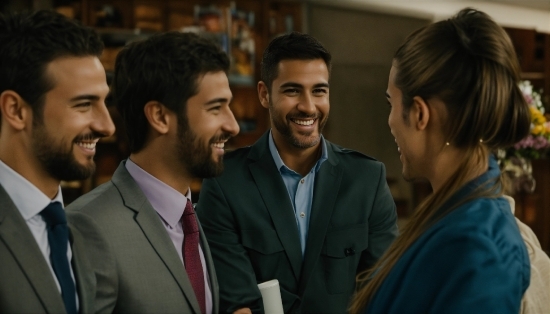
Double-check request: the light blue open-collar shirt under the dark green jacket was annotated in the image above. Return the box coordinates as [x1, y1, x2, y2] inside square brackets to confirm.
[269, 131, 328, 255]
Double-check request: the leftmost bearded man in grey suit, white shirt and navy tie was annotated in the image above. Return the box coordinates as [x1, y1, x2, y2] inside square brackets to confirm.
[0, 11, 116, 313]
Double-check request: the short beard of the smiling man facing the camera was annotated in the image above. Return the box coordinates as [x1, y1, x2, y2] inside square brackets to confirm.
[269, 96, 328, 148]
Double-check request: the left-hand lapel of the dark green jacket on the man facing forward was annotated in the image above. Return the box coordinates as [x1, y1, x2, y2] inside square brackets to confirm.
[249, 132, 302, 280]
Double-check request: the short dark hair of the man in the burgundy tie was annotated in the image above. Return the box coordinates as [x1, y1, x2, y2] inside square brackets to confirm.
[111, 32, 229, 153]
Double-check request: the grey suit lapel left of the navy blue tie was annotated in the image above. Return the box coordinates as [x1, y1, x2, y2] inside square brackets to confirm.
[0, 186, 65, 313]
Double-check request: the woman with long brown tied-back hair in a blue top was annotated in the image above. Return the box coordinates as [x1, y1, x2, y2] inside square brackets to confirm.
[350, 9, 530, 313]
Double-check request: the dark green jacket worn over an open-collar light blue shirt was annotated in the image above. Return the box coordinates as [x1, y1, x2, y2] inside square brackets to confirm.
[197, 132, 397, 313]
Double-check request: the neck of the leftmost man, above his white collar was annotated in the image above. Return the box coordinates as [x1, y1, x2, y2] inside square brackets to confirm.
[0, 136, 60, 199]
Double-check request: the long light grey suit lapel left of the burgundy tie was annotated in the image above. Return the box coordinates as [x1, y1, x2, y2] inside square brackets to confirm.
[112, 162, 200, 313]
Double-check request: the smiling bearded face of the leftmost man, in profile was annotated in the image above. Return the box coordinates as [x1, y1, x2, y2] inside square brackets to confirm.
[31, 57, 115, 181]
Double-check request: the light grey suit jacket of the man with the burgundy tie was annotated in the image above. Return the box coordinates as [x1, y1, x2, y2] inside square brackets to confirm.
[67, 162, 219, 313]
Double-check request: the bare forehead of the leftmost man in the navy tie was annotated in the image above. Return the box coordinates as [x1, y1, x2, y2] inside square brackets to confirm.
[45, 56, 109, 98]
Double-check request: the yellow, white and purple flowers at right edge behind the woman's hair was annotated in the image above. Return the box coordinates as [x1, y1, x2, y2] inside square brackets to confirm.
[507, 81, 550, 159]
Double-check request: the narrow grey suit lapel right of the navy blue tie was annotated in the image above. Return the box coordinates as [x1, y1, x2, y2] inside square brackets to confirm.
[69, 226, 96, 313]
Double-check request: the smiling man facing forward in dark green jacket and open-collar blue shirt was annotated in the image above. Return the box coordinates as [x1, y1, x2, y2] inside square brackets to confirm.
[197, 33, 397, 313]
